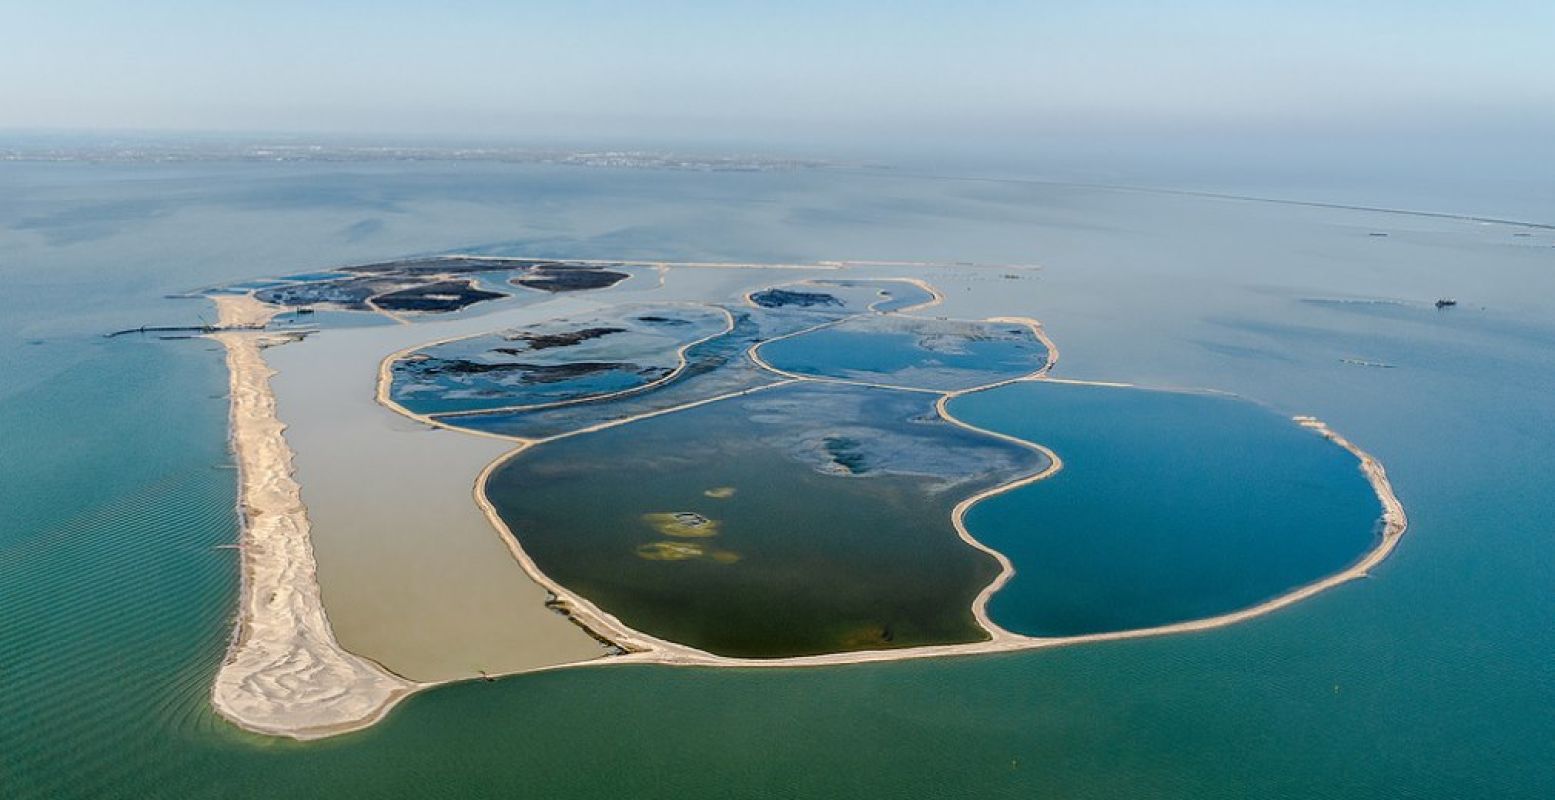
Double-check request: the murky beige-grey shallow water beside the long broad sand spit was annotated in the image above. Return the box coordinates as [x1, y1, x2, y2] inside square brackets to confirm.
[266, 297, 605, 682]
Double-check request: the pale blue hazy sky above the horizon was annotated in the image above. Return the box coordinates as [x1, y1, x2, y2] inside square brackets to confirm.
[0, 0, 1555, 147]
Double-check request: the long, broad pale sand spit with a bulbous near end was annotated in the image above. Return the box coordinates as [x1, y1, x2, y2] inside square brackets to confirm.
[211, 296, 418, 739]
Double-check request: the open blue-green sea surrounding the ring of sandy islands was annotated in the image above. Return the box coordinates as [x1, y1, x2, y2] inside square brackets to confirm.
[0, 163, 1555, 798]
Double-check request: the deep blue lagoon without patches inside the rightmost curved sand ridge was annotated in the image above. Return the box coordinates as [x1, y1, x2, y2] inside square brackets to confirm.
[950, 383, 1381, 635]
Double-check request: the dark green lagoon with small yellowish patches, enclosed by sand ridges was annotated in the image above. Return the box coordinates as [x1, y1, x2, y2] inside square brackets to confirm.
[487, 386, 1043, 657]
